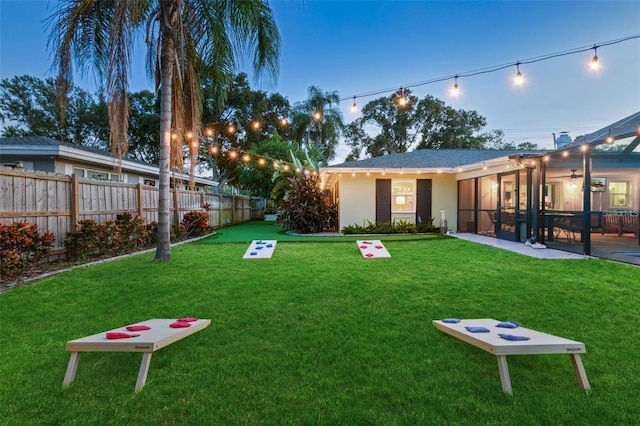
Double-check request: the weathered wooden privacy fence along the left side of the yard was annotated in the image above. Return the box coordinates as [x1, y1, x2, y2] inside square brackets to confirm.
[0, 167, 265, 254]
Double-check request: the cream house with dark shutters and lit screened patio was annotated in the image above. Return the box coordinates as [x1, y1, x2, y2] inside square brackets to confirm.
[320, 112, 640, 260]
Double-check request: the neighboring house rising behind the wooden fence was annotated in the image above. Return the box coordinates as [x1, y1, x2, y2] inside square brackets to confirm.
[0, 136, 218, 192]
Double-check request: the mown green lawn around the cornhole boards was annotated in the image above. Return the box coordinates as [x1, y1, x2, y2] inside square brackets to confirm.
[0, 227, 640, 425]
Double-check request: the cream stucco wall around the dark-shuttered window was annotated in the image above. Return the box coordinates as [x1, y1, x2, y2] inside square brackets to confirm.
[338, 173, 458, 231]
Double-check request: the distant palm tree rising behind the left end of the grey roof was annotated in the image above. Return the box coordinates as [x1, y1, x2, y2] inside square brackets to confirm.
[292, 86, 344, 163]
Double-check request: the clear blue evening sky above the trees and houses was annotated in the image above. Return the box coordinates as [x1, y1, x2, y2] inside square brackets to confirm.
[0, 0, 640, 163]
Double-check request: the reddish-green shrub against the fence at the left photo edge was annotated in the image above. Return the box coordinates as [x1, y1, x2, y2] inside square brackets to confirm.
[0, 221, 55, 277]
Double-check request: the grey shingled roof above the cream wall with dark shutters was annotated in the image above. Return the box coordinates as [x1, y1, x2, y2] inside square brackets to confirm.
[322, 149, 546, 171]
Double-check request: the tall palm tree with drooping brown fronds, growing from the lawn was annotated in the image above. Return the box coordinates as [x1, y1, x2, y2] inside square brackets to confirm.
[49, 0, 280, 261]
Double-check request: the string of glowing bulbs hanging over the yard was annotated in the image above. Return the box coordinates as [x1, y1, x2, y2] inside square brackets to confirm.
[172, 34, 640, 174]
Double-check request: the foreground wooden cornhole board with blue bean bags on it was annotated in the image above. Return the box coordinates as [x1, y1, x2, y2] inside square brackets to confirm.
[433, 318, 590, 395]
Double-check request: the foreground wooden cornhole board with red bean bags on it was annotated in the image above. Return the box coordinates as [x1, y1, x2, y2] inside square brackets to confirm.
[62, 319, 211, 392]
